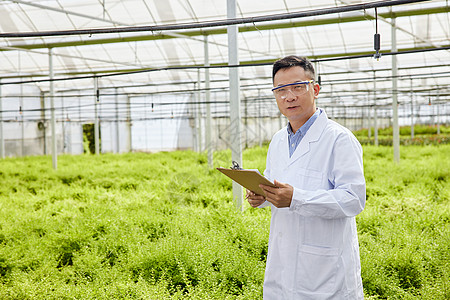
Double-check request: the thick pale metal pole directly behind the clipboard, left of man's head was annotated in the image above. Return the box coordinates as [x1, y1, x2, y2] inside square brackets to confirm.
[227, 0, 243, 210]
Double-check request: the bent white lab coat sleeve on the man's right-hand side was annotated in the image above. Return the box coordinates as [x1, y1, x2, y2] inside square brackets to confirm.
[290, 133, 366, 219]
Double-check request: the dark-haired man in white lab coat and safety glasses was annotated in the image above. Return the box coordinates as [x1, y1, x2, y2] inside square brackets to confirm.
[247, 56, 366, 300]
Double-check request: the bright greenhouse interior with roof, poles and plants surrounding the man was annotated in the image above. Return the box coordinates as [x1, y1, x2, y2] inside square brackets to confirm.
[0, 0, 450, 299]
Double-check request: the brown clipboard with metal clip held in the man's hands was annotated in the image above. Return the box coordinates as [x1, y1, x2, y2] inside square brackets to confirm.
[216, 162, 277, 196]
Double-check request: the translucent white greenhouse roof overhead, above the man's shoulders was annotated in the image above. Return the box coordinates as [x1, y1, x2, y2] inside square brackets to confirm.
[0, 0, 450, 108]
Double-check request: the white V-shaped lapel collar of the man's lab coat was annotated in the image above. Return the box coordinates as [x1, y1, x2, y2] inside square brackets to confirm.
[281, 108, 328, 166]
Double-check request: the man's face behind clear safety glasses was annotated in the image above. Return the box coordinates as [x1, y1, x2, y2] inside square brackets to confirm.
[273, 66, 320, 130]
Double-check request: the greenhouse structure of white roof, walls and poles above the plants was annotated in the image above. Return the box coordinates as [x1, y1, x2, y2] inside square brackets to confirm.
[0, 0, 450, 164]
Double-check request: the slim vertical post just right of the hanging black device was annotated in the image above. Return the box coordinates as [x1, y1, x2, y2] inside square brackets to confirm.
[391, 17, 400, 162]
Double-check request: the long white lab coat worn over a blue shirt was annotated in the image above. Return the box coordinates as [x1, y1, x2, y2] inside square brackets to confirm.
[261, 111, 366, 300]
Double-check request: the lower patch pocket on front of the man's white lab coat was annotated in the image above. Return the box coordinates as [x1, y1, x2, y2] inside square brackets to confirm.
[296, 245, 339, 293]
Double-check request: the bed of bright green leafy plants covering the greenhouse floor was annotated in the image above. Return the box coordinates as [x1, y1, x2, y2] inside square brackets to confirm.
[0, 145, 450, 299]
